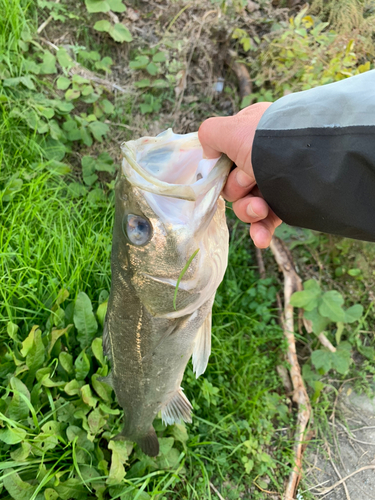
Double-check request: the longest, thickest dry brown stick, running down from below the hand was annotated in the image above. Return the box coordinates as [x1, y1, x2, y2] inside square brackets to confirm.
[270, 237, 311, 500]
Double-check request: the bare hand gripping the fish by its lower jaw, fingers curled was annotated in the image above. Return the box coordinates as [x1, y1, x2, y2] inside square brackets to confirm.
[198, 102, 282, 248]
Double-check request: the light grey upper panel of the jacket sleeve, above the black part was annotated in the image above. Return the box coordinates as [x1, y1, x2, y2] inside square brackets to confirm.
[257, 70, 375, 130]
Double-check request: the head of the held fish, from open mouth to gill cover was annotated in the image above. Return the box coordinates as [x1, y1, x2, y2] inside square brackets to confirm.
[113, 129, 232, 318]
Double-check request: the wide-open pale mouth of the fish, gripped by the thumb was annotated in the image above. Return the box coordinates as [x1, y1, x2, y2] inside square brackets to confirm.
[121, 129, 232, 201]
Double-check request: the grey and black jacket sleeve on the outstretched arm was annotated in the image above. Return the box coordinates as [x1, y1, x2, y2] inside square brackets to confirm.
[252, 70, 375, 241]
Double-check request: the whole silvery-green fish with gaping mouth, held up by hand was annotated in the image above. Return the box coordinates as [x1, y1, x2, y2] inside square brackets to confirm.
[103, 129, 232, 456]
